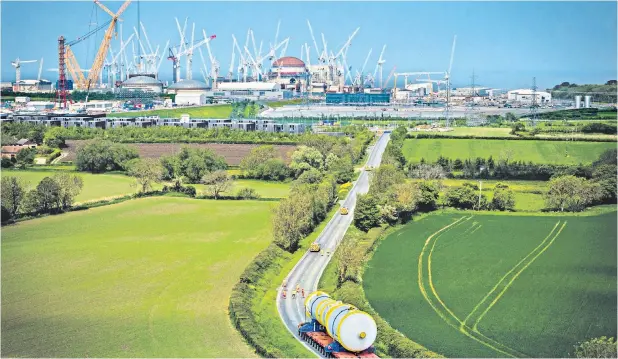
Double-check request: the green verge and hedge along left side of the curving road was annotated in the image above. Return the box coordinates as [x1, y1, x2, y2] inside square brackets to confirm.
[229, 205, 339, 358]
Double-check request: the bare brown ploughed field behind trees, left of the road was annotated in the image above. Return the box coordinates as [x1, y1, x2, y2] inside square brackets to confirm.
[63, 140, 296, 166]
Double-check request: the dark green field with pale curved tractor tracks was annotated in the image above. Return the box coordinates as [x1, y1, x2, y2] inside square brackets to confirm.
[363, 212, 617, 357]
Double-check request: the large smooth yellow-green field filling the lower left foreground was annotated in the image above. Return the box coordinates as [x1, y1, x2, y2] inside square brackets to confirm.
[1, 197, 273, 358]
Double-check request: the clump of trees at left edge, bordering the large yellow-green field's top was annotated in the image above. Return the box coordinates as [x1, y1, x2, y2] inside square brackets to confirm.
[2, 172, 84, 223]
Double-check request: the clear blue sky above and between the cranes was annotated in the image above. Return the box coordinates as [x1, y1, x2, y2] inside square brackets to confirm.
[1, 1, 617, 88]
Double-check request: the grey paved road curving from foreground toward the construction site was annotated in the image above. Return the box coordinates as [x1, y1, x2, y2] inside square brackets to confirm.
[277, 133, 390, 356]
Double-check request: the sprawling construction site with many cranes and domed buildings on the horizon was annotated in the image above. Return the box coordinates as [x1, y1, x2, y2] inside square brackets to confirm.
[2, 0, 608, 120]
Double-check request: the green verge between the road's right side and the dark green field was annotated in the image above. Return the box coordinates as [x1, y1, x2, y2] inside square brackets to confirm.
[318, 224, 442, 358]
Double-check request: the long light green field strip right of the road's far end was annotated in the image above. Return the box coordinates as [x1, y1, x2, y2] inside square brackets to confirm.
[402, 139, 616, 165]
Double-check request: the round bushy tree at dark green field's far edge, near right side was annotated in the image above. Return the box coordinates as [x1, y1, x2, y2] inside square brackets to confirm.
[545, 175, 603, 212]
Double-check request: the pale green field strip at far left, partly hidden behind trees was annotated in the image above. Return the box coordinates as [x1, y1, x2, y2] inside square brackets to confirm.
[2, 169, 137, 203]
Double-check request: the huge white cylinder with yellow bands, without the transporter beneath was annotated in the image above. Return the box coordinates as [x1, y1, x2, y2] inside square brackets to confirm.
[305, 291, 378, 352]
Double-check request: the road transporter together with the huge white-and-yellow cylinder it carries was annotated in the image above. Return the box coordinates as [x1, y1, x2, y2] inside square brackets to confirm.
[298, 291, 378, 358]
